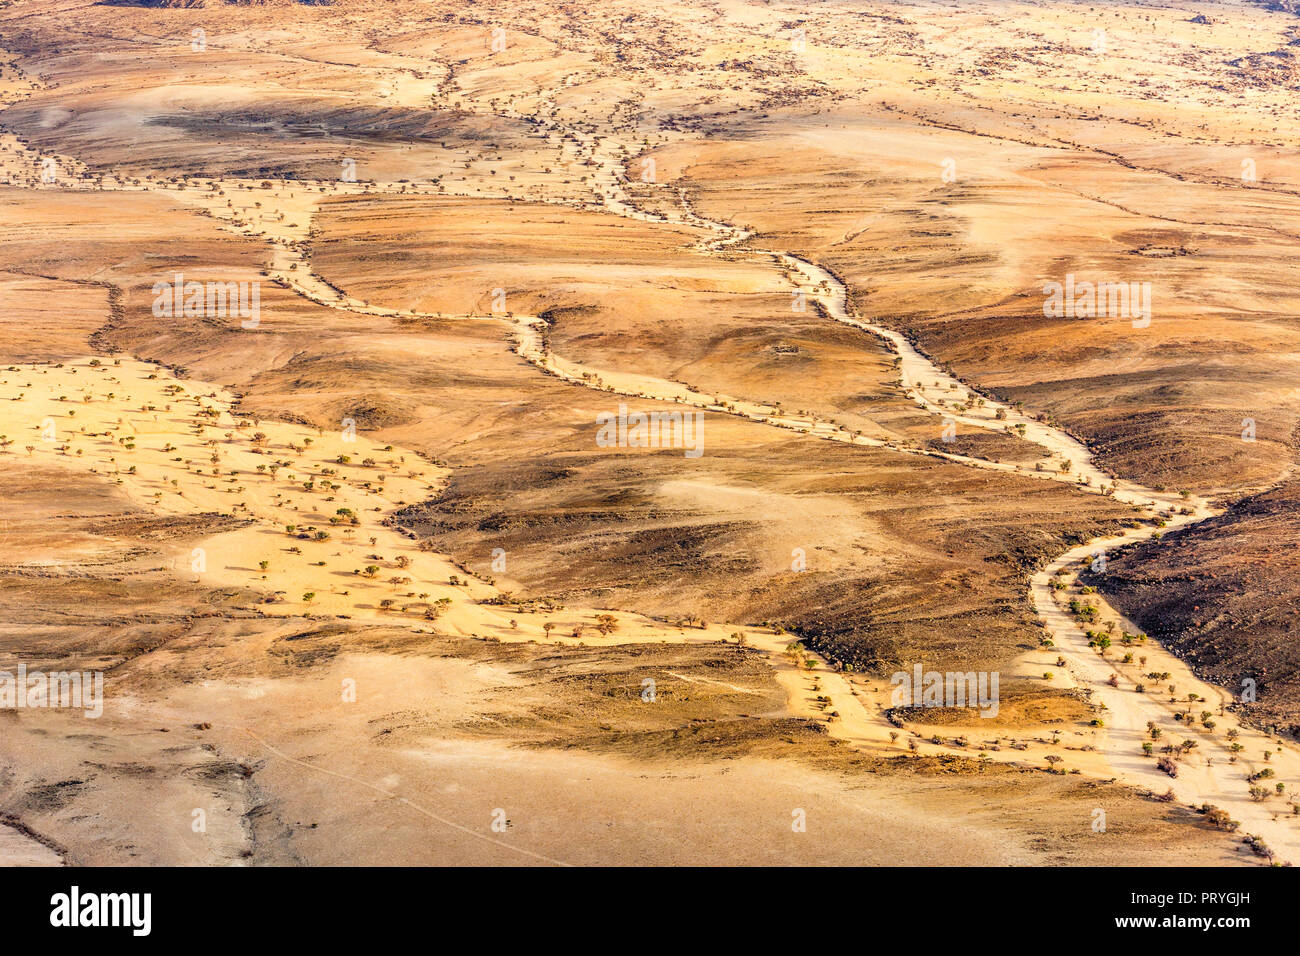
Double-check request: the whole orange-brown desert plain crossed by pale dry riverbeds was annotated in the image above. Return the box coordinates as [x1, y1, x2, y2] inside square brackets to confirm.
[0, 0, 1300, 866]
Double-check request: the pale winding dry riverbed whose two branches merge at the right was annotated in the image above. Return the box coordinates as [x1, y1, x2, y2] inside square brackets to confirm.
[12, 111, 1300, 860]
